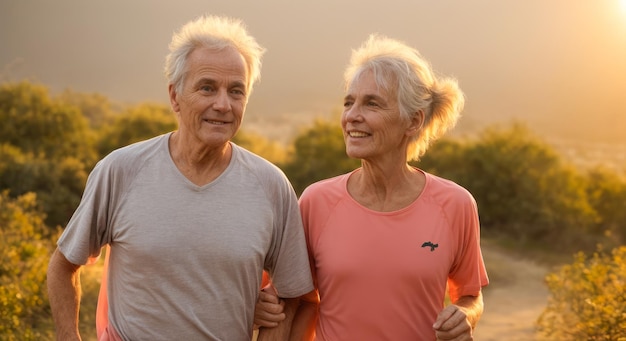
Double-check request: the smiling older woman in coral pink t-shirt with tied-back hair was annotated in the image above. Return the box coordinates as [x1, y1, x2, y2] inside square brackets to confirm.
[257, 35, 488, 341]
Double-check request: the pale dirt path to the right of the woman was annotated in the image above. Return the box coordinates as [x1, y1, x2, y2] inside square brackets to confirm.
[474, 246, 548, 341]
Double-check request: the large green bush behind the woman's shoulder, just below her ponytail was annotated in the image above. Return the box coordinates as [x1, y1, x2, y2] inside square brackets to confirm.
[418, 124, 599, 250]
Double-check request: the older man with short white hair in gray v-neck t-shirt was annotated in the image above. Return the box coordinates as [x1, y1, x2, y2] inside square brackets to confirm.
[48, 16, 313, 340]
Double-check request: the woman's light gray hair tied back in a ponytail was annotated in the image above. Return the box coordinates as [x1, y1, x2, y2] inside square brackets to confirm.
[344, 34, 465, 161]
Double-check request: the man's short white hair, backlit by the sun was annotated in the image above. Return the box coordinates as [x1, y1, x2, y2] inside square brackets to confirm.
[165, 15, 265, 95]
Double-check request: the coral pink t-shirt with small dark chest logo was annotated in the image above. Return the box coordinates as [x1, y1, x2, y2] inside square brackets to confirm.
[300, 170, 488, 341]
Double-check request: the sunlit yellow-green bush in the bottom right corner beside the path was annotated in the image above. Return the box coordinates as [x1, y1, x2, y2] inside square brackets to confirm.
[538, 246, 626, 341]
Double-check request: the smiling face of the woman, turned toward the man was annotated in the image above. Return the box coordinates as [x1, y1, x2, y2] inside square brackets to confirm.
[341, 71, 411, 162]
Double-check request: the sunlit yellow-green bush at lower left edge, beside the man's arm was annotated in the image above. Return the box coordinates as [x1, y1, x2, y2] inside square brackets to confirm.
[0, 191, 58, 340]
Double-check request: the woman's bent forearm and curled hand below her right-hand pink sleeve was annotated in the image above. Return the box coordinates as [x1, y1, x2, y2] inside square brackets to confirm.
[433, 291, 484, 340]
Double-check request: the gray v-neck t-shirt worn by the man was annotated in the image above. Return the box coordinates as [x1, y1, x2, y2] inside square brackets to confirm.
[58, 134, 313, 340]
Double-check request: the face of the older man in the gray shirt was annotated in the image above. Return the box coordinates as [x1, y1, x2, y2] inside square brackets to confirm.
[169, 47, 248, 148]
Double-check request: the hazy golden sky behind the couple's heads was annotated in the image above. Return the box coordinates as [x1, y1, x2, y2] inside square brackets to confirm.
[0, 0, 626, 143]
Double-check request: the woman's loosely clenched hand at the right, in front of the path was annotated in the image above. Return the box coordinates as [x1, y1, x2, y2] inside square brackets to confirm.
[433, 304, 474, 341]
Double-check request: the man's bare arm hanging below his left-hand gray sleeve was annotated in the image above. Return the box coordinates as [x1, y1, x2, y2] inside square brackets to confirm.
[48, 249, 81, 340]
